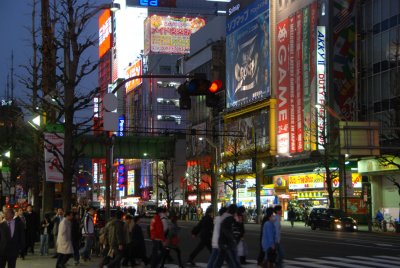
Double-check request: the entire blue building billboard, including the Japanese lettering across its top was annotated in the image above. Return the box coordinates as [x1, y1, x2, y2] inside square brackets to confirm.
[226, 0, 270, 108]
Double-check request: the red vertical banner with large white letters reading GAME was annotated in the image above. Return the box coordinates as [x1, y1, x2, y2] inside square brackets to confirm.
[276, 19, 290, 154]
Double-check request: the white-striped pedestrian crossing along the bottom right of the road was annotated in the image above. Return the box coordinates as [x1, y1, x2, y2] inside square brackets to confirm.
[160, 255, 400, 268]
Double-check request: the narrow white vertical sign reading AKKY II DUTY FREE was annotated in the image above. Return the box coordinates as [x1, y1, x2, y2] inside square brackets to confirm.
[317, 26, 327, 149]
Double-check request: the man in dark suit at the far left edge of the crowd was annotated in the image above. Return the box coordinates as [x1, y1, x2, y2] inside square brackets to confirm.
[0, 208, 25, 268]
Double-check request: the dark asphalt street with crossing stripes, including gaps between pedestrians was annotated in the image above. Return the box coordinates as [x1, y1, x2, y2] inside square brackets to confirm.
[17, 220, 400, 268]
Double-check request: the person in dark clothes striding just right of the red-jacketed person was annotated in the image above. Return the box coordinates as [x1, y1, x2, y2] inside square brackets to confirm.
[187, 207, 214, 265]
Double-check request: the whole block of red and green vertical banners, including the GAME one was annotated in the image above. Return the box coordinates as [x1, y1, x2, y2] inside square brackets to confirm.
[274, 0, 318, 155]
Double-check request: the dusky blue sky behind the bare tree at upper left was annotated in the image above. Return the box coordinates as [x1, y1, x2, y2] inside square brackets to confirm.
[0, 0, 106, 105]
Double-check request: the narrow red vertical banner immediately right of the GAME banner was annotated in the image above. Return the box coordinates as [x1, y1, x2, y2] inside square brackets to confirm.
[289, 16, 297, 153]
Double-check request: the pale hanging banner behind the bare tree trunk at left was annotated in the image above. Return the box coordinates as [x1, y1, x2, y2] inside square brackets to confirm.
[44, 133, 64, 182]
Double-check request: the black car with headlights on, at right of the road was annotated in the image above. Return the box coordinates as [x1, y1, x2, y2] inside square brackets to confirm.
[308, 208, 358, 231]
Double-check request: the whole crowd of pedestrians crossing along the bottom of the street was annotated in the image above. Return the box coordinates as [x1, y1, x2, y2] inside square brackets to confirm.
[0, 204, 284, 268]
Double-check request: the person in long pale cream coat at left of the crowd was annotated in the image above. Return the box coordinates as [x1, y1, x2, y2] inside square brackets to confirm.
[56, 211, 74, 268]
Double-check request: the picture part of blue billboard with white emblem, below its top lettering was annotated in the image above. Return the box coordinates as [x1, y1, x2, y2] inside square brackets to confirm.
[226, 12, 270, 108]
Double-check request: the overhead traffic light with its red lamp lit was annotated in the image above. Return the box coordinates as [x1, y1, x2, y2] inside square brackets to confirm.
[178, 78, 222, 110]
